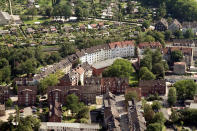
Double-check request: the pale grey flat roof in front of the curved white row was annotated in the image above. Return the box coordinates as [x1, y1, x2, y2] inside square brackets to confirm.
[92, 57, 122, 69]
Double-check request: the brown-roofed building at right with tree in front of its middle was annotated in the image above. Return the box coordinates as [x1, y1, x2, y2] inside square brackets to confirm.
[163, 47, 193, 66]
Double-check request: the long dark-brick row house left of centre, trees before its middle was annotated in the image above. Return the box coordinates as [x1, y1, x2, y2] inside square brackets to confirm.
[47, 85, 100, 104]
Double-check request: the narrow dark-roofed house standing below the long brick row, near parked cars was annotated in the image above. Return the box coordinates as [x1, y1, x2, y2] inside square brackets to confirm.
[48, 101, 62, 122]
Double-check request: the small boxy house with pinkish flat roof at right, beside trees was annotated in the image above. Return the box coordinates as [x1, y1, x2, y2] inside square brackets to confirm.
[174, 62, 186, 75]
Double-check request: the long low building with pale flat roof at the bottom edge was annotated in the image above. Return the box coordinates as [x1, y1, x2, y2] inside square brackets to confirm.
[39, 122, 100, 131]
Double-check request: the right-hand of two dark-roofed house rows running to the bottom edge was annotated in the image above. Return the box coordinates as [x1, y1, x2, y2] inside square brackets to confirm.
[128, 100, 146, 131]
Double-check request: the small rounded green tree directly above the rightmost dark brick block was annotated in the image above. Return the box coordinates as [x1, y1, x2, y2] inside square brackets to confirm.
[139, 67, 156, 80]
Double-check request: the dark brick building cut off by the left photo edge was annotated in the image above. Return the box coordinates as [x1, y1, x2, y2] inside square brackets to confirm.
[0, 86, 9, 104]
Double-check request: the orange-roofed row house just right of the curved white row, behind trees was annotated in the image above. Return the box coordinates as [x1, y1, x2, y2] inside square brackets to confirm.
[138, 42, 162, 55]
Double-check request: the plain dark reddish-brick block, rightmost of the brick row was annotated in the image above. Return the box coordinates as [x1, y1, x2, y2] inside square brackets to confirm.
[139, 80, 166, 96]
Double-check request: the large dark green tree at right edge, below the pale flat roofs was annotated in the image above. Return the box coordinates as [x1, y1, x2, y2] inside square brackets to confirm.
[174, 80, 197, 100]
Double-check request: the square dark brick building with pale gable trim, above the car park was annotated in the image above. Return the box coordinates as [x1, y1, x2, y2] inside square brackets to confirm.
[18, 86, 37, 106]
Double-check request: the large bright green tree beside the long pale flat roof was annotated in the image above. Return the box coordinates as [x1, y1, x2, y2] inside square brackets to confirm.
[103, 59, 134, 77]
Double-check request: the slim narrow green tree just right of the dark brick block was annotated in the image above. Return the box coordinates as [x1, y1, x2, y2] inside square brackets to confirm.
[168, 87, 177, 106]
